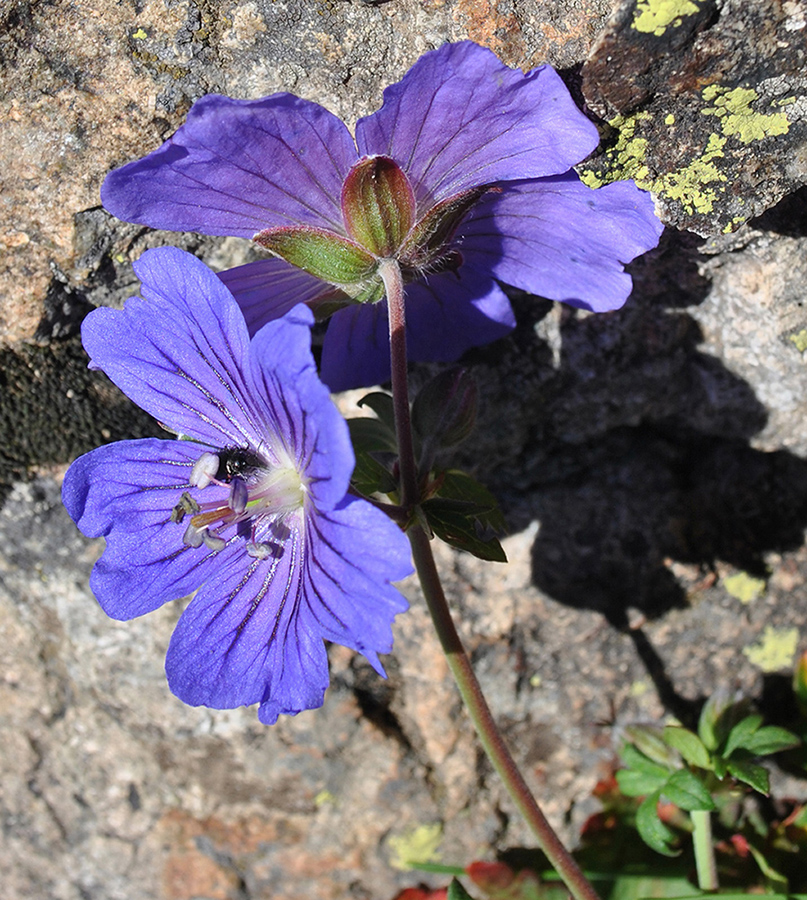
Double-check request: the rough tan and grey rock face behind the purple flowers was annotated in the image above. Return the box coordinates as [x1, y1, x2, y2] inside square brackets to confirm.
[0, 0, 807, 900]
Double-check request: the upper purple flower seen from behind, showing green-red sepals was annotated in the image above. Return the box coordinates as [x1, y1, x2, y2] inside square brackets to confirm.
[101, 42, 661, 390]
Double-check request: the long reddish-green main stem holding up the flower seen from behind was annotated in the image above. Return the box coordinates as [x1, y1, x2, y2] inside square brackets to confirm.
[379, 259, 599, 900]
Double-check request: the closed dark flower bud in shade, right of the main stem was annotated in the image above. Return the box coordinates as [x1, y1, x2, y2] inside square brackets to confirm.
[412, 367, 478, 447]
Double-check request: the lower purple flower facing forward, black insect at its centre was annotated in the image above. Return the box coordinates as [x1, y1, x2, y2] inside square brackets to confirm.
[62, 248, 412, 724]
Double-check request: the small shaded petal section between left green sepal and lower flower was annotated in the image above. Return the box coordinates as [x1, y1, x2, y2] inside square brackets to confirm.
[219, 257, 331, 334]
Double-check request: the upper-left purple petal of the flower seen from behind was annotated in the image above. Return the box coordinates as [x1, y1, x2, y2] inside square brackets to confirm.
[101, 94, 357, 238]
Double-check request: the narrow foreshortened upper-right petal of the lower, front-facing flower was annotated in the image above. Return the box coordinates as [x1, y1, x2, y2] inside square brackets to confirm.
[251, 306, 355, 510]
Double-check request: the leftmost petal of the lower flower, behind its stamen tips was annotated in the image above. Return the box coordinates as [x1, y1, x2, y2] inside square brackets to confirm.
[62, 438, 233, 619]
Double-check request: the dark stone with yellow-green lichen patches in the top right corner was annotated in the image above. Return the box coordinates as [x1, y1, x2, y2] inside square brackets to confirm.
[583, 0, 807, 236]
